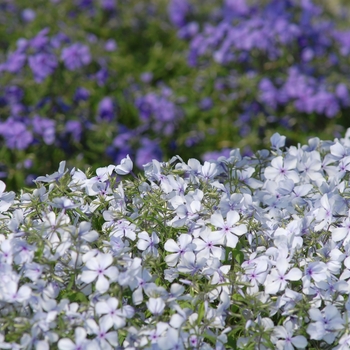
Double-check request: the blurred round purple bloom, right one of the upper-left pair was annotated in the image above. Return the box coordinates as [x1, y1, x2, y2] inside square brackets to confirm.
[61, 43, 91, 71]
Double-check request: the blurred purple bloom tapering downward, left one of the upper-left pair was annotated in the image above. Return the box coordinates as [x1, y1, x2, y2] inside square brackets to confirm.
[28, 52, 58, 83]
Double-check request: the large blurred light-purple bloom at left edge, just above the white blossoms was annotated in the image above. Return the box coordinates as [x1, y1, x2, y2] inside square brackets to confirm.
[0, 117, 33, 150]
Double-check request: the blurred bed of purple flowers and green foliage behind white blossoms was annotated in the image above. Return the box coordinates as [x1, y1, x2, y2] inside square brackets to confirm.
[0, 0, 350, 189]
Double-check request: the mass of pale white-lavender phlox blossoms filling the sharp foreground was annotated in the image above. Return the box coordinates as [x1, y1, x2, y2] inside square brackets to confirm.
[0, 130, 350, 350]
